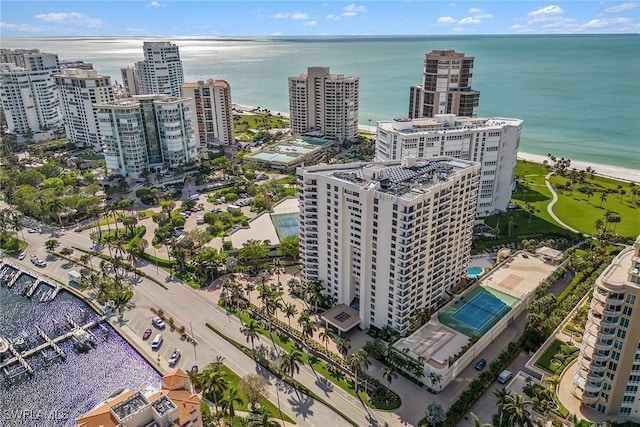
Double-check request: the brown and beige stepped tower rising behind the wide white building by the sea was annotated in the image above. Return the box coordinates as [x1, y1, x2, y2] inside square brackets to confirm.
[409, 50, 480, 118]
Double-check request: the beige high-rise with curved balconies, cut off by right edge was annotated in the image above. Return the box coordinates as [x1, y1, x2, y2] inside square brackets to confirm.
[572, 236, 640, 422]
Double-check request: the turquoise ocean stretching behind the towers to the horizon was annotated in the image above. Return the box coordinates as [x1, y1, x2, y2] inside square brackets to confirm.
[0, 35, 640, 169]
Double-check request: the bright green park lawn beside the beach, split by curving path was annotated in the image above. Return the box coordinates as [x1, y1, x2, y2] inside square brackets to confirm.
[512, 160, 640, 237]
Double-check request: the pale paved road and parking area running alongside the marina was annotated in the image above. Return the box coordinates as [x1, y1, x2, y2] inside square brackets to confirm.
[13, 221, 402, 426]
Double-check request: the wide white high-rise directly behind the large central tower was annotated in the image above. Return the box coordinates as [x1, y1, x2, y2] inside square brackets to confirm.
[375, 114, 522, 216]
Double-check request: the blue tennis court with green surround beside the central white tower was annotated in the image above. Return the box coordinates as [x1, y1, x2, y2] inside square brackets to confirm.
[439, 286, 519, 337]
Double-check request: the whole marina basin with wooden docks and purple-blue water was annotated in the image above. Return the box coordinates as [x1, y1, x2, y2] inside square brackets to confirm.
[0, 260, 159, 427]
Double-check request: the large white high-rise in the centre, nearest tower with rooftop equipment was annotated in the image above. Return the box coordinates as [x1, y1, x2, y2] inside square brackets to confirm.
[297, 157, 480, 331]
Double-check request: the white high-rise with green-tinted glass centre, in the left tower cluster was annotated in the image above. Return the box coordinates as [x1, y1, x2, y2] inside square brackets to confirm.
[95, 95, 198, 178]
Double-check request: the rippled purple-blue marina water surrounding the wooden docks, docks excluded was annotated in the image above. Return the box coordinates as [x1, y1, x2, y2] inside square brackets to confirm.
[0, 270, 160, 427]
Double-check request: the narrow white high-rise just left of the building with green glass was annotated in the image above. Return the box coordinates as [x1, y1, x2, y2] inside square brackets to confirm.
[55, 68, 115, 152]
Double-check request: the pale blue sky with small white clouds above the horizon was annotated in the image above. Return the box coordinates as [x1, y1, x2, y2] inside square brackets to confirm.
[0, 0, 640, 37]
